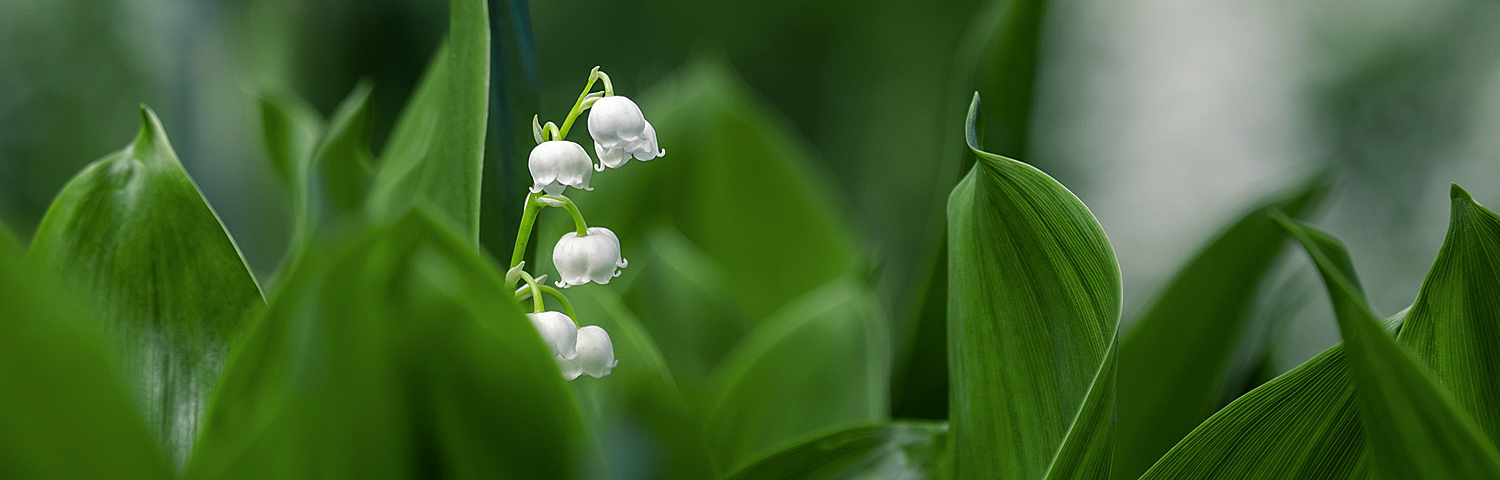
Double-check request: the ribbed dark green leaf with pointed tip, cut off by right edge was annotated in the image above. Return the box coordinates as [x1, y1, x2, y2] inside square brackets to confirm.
[1397, 185, 1500, 444]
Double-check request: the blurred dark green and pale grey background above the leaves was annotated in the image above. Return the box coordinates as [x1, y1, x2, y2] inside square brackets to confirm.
[0, 0, 1500, 423]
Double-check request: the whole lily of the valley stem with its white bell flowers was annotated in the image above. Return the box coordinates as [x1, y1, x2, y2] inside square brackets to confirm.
[506, 68, 666, 380]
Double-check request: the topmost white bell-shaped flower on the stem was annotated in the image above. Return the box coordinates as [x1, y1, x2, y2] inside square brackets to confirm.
[588, 95, 666, 171]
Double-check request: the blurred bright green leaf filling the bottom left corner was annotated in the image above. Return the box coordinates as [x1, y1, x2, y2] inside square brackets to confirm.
[0, 219, 173, 480]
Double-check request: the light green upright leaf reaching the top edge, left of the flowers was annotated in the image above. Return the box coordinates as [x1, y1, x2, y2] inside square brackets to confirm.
[371, 0, 491, 245]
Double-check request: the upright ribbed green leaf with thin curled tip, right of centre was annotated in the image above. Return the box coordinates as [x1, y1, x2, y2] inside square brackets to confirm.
[948, 95, 1121, 479]
